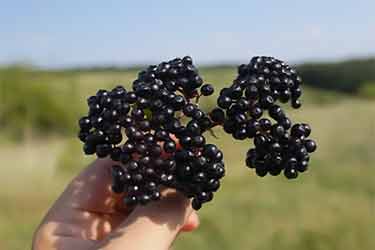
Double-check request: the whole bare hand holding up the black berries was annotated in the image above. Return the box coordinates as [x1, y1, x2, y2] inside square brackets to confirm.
[33, 159, 199, 250]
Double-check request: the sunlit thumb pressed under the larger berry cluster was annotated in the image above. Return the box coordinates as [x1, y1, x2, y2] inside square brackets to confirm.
[95, 189, 198, 250]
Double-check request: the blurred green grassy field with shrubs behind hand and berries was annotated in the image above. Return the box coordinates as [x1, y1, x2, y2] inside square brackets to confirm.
[0, 68, 375, 250]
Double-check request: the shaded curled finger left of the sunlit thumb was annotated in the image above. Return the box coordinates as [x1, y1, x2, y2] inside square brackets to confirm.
[36, 159, 130, 240]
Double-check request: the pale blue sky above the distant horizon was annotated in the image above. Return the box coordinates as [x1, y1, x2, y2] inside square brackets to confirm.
[0, 0, 375, 67]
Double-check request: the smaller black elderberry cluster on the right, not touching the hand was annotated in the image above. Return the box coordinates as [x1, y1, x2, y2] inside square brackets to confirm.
[211, 57, 316, 179]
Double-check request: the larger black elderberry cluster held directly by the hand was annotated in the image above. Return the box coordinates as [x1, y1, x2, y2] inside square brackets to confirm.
[79, 56, 225, 210]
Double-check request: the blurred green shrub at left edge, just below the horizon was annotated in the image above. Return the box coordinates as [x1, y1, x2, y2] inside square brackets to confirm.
[0, 68, 81, 137]
